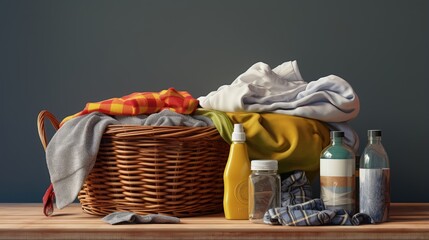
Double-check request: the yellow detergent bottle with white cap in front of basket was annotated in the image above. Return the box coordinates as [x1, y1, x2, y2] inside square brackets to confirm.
[223, 124, 250, 220]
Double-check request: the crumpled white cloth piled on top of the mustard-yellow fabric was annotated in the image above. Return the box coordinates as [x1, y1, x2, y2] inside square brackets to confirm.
[198, 61, 360, 151]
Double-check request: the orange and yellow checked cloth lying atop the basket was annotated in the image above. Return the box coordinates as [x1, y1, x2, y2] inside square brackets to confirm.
[60, 88, 198, 126]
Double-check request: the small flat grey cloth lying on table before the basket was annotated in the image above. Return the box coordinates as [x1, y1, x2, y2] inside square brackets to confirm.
[101, 212, 180, 225]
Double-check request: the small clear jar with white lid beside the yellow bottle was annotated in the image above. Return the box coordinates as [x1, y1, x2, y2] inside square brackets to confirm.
[249, 160, 281, 223]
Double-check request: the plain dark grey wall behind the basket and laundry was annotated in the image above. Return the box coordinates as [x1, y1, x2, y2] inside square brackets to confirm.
[0, 0, 429, 202]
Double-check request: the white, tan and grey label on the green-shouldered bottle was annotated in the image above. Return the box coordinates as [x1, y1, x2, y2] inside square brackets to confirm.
[320, 159, 356, 213]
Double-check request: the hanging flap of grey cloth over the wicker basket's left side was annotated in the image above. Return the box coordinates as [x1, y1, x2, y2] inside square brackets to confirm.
[46, 112, 118, 209]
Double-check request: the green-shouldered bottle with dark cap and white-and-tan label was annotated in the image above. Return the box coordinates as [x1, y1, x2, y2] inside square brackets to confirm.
[320, 131, 355, 215]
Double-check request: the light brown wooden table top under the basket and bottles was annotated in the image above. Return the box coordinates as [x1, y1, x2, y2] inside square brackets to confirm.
[0, 203, 429, 240]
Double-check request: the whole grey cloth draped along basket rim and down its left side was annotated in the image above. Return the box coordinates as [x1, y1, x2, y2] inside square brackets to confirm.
[45, 110, 212, 209]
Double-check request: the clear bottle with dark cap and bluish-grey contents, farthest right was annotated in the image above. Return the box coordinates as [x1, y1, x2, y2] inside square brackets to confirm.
[359, 130, 390, 223]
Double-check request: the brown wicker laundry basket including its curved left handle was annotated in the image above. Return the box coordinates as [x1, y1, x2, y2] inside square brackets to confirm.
[38, 111, 229, 217]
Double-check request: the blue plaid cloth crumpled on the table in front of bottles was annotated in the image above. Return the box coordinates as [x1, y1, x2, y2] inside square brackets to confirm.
[264, 171, 375, 226]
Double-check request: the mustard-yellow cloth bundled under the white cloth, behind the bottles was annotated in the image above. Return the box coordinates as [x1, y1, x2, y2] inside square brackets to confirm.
[226, 112, 330, 179]
